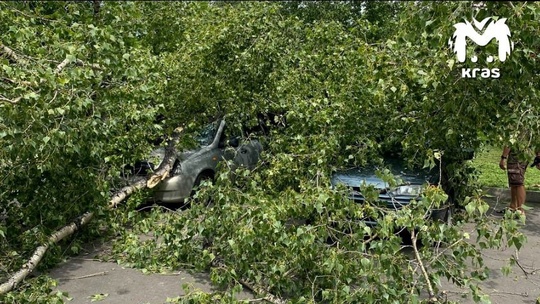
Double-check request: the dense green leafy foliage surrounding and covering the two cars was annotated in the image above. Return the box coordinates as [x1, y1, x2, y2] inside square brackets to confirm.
[0, 1, 540, 303]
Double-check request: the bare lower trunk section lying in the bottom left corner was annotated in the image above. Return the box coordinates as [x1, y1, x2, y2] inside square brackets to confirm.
[0, 212, 94, 294]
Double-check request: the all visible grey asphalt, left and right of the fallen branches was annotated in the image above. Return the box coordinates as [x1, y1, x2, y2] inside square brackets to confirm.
[50, 191, 540, 304]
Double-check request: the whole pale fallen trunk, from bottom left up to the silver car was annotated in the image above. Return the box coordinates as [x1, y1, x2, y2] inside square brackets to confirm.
[0, 128, 182, 295]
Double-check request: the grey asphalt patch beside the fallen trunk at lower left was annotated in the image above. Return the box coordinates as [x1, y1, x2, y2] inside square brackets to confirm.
[49, 236, 253, 304]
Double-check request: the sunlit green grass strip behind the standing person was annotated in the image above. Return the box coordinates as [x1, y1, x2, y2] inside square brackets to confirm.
[473, 147, 540, 190]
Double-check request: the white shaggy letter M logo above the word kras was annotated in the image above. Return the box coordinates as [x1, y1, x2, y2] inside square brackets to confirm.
[448, 17, 514, 62]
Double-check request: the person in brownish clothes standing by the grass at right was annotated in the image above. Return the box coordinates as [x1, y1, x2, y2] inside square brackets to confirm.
[499, 147, 540, 214]
